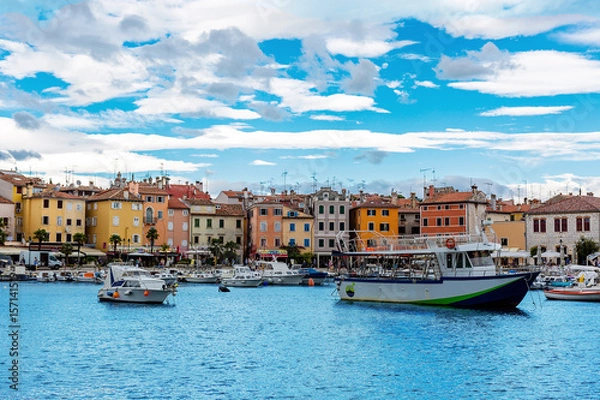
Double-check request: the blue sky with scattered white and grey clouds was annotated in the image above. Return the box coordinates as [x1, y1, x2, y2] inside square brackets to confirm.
[0, 0, 600, 202]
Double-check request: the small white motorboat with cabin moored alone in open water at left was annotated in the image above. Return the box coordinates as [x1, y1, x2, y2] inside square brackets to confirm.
[98, 263, 177, 304]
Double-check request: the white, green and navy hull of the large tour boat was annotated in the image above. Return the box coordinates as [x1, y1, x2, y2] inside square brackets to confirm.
[336, 273, 537, 308]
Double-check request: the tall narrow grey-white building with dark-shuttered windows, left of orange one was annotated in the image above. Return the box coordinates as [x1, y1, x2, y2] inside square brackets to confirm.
[308, 186, 351, 267]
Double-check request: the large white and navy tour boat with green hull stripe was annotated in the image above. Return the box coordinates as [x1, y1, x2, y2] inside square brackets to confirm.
[332, 229, 539, 308]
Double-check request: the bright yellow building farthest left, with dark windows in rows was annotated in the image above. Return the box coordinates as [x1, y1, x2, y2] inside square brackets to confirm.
[22, 185, 85, 243]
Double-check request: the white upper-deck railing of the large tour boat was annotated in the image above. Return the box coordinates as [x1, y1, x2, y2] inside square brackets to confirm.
[336, 231, 493, 253]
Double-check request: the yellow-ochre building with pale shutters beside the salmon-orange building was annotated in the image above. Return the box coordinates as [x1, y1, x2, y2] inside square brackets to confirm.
[85, 189, 145, 252]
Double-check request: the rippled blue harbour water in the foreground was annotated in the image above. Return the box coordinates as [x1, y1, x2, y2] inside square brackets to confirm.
[0, 282, 600, 400]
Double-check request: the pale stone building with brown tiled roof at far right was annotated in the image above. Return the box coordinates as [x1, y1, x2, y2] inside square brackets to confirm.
[525, 193, 600, 265]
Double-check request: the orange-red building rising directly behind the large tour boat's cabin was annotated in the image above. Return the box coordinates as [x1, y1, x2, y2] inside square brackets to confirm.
[420, 185, 487, 236]
